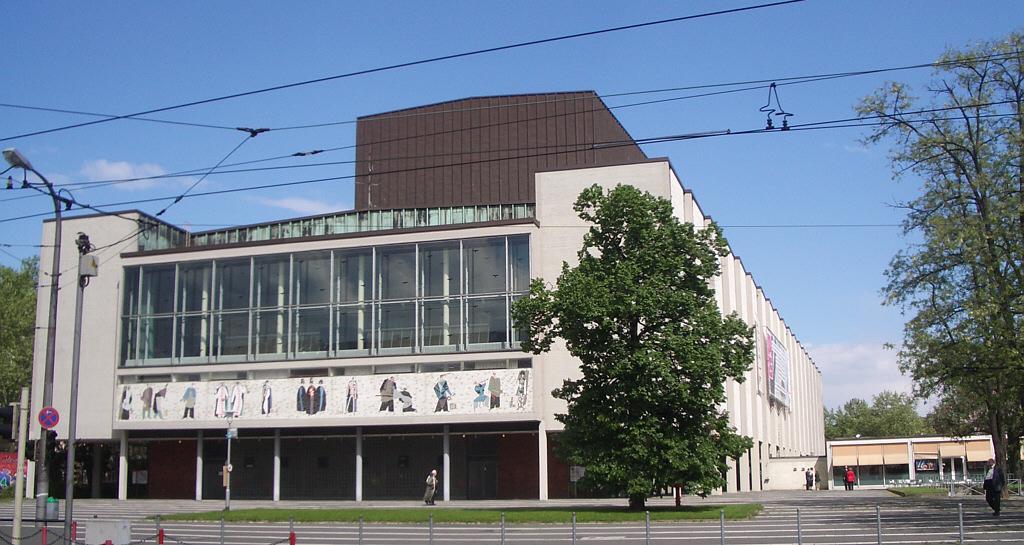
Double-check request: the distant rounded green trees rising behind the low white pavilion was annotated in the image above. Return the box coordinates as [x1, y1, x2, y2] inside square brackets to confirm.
[825, 391, 933, 439]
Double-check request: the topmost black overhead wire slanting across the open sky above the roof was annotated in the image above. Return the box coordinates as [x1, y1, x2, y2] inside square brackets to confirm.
[0, 0, 806, 141]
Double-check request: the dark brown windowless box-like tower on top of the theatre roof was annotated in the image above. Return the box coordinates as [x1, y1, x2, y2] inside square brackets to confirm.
[355, 91, 647, 210]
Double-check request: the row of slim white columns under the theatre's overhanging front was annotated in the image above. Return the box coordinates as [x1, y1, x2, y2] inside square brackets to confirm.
[118, 421, 548, 502]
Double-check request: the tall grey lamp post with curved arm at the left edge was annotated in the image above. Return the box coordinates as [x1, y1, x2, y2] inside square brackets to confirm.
[3, 148, 72, 519]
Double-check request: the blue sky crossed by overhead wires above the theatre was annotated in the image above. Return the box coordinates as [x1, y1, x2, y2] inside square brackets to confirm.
[0, 0, 1024, 407]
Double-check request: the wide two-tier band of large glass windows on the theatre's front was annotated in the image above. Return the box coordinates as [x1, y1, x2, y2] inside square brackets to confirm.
[121, 235, 530, 367]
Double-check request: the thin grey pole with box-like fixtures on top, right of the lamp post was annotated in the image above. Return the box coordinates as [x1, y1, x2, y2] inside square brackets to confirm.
[65, 233, 99, 536]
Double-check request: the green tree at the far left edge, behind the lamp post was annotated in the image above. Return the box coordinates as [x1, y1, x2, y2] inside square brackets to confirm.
[0, 257, 39, 405]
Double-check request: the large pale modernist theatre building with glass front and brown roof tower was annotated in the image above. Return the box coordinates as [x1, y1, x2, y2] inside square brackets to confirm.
[33, 92, 824, 500]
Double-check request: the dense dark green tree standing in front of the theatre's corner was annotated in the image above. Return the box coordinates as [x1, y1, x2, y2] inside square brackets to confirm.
[513, 185, 754, 508]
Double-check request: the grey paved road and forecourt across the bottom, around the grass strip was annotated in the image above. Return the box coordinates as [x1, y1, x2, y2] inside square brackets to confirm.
[0, 491, 1024, 545]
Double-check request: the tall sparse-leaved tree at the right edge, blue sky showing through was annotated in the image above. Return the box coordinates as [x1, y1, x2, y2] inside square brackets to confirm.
[857, 33, 1024, 479]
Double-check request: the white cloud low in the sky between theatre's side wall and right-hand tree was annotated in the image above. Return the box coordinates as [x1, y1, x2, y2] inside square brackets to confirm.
[807, 342, 912, 409]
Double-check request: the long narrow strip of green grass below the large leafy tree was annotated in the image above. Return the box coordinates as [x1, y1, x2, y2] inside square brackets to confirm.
[161, 503, 762, 523]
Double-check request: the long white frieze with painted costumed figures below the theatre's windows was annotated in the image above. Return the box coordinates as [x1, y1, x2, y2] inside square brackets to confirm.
[115, 369, 532, 422]
